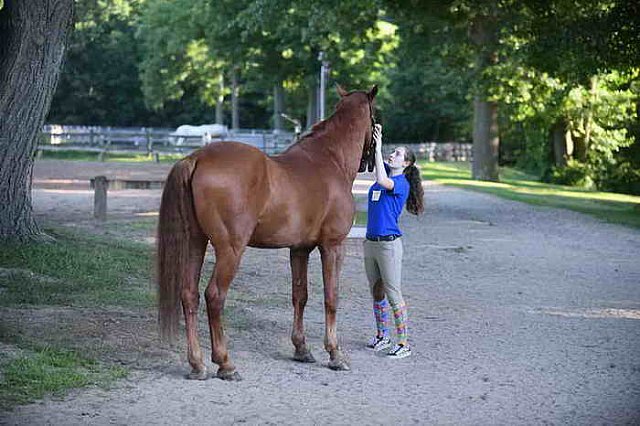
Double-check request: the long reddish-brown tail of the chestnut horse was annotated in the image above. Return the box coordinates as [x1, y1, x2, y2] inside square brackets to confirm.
[156, 156, 200, 342]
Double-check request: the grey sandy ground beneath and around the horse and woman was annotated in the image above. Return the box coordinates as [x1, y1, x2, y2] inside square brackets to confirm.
[0, 162, 640, 425]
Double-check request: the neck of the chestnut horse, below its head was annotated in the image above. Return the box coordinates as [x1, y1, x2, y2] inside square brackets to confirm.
[304, 111, 368, 181]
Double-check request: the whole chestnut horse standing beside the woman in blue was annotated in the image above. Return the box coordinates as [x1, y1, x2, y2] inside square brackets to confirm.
[157, 86, 377, 380]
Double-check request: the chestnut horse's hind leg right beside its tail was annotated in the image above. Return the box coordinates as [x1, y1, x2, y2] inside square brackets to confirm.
[180, 235, 207, 380]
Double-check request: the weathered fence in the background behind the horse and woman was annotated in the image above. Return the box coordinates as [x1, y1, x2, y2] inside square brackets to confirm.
[38, 125, 472, 161]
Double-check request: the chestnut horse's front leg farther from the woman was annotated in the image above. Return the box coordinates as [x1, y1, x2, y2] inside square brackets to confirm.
[290, 248, 316, 362]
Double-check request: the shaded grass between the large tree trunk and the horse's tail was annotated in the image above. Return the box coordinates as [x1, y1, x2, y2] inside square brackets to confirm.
[0, 230, 153, 307]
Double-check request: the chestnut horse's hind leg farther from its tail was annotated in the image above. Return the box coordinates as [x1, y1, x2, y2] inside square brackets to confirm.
[205, 245, 244, 380]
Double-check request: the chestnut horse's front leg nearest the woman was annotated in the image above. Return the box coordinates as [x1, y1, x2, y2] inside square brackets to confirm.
[320, 244, 350, 371]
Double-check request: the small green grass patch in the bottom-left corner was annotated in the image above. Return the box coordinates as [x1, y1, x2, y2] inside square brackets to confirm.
[0, 347, 128, 409]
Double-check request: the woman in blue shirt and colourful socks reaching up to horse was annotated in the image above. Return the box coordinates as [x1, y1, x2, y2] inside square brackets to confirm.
[364, 124, 424, 359]
